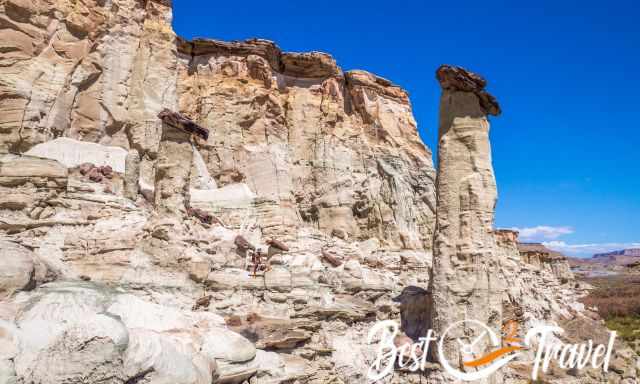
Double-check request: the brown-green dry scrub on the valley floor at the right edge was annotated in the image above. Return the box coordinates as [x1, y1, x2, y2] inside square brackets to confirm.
[583, 276, 640, 341]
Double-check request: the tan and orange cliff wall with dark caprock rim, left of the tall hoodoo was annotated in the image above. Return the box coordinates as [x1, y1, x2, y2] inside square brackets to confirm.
[178, 39, 435, 250]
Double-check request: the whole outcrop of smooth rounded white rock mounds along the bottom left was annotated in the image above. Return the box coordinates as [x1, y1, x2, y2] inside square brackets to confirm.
[5, 282, 256, 384]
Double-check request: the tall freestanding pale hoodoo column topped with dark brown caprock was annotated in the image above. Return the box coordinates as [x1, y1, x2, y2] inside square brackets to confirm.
[431, 65, 503, 371]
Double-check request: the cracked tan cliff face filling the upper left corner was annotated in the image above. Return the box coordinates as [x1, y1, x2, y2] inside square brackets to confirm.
[0, 0, 177, 153]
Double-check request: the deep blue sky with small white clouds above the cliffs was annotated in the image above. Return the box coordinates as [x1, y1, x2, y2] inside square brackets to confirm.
[174, 0, 640, 256]
